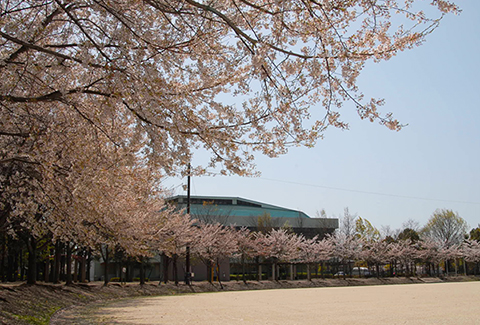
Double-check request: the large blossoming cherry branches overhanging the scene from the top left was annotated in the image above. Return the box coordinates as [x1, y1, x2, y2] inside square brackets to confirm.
[0, 0, 458, 174]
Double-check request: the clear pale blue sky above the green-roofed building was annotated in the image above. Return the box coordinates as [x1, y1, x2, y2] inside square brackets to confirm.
[165, 0, 480, 229]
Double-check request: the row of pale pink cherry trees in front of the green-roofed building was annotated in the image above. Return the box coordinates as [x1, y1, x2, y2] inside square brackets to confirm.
[161, 216, 480, 279]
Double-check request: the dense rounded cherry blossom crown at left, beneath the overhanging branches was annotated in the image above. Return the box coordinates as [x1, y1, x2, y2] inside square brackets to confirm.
[1, 112, 171, 284]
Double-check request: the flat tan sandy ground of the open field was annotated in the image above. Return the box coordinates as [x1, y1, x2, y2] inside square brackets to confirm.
[90, 282, 480, 324]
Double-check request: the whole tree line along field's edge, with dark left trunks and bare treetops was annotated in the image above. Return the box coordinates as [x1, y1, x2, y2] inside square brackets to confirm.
[0, 206, 480, 284]
